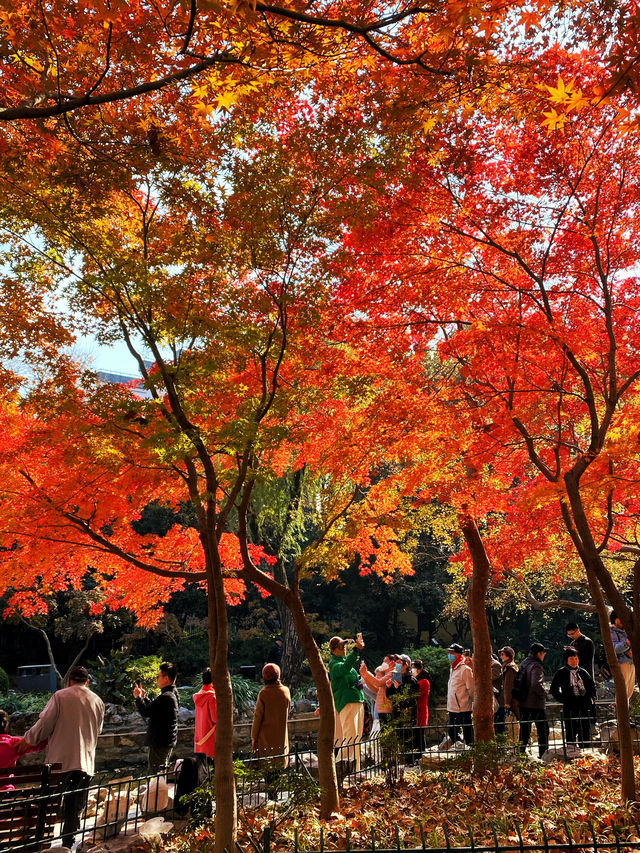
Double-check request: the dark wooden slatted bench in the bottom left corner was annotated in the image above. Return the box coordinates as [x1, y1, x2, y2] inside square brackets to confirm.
[0, 764, 64, 851]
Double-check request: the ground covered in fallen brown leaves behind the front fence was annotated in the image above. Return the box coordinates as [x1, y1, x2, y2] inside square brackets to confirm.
[174, 754, 640, 850]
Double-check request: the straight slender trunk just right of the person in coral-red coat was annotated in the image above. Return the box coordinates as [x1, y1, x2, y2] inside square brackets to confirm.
[203, 537, 237, 853]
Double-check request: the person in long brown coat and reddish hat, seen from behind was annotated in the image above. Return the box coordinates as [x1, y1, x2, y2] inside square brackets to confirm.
[251, 663, 291, 767]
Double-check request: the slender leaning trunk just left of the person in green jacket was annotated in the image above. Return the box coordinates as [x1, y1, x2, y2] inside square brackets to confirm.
[286, 588, 340, 820]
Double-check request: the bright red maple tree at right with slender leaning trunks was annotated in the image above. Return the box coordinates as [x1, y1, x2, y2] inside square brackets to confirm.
[342, 50, 640, 799]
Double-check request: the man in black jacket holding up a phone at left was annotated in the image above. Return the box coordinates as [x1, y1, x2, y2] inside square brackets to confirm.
[133, 663, 178, 773]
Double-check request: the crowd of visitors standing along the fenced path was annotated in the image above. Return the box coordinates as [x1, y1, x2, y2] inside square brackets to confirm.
[0, 611, 635, 847]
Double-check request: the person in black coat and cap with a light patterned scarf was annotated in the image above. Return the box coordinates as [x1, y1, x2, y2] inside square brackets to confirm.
[551, 646, 596, 749]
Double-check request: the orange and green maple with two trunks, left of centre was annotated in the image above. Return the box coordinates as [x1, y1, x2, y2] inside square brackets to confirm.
[0, 95, 424, 850]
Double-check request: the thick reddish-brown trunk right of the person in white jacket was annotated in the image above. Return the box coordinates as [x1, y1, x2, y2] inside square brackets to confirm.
[458, 514, 494, 742]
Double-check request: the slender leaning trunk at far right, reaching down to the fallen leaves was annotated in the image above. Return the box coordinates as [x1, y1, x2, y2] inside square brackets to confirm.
[587, 566, 636, 802]
